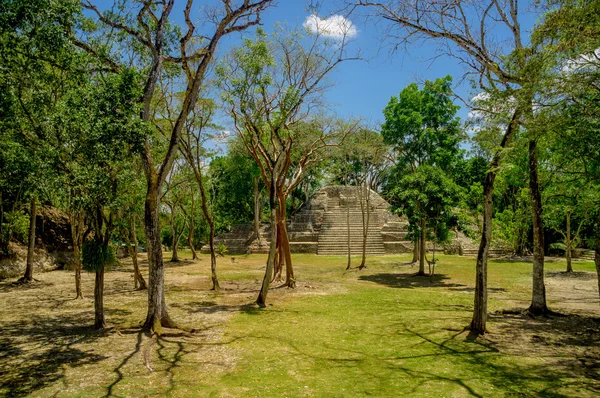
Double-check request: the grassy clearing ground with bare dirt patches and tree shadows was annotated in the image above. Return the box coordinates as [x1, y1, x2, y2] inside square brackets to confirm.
[0, 252, 600, 397]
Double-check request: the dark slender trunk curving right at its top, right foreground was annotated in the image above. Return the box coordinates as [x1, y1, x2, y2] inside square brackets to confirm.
[469, 108, 521, 334]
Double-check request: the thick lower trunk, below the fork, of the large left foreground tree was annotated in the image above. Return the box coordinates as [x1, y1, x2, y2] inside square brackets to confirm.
[142, 179, 176, 334]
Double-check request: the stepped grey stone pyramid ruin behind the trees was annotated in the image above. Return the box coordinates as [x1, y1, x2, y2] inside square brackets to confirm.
[202, 186, 413, 255]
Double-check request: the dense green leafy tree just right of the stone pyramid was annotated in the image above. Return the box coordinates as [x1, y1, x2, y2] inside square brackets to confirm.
[381, 76, 463, 275]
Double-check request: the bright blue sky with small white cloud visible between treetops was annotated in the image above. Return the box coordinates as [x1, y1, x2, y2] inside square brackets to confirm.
[91, 0, 535, 131]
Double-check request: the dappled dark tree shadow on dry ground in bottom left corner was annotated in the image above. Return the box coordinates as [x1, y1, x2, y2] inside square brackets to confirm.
[0, 314, 107, 397]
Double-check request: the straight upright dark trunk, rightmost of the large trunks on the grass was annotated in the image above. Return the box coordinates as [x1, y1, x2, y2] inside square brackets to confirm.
[529, 140, 548, 314]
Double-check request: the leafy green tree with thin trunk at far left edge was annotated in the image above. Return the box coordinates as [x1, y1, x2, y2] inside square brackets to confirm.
[0, 0, 76, 283]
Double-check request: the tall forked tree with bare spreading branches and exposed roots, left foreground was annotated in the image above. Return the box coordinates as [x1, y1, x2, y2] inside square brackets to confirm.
[74, 0, 272, 334]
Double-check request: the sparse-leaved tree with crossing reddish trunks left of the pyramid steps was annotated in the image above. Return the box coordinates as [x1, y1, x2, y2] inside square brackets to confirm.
[218, 31, 356, 307]
